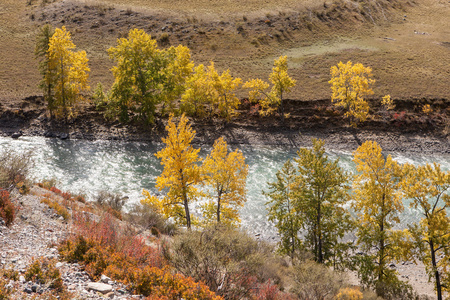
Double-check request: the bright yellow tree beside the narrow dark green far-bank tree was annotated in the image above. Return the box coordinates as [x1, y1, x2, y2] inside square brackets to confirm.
[48, 26, 90, 120]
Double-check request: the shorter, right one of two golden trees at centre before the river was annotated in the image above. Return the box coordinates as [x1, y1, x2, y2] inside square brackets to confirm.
[202, 138, 248, 225]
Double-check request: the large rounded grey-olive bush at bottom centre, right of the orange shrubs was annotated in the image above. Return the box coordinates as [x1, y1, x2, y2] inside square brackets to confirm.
[164, 227, 280, 299]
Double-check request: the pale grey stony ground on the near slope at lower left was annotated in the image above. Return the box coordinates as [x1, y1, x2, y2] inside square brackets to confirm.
[0, 186, 141, 300]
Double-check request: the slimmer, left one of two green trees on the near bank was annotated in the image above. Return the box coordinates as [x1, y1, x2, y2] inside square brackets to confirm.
[264, 160, 302, 260]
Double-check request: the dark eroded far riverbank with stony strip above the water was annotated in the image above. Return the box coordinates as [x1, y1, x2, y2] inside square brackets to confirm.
[0, 96, 450, 155]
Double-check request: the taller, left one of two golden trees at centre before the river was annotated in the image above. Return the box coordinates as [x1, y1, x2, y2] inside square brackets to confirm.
[142, 114, 201, 229]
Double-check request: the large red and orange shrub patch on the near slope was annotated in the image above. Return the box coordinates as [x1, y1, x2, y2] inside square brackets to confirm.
[59, 214, 221, 300]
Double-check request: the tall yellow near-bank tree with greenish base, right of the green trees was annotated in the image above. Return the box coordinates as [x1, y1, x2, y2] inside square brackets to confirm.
[353, 141, 403, 297]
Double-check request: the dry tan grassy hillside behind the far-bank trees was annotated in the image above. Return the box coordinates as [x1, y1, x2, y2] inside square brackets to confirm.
[0, 0, 450, 105]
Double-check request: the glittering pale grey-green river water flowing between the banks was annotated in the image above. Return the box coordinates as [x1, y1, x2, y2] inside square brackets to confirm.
[0, 137, 450, 239]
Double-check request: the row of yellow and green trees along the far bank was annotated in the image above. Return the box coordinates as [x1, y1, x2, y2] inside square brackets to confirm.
[35, 25, 393, 126]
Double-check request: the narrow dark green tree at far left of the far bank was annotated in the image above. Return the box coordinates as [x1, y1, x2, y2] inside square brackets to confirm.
[34, 24, 55, 117]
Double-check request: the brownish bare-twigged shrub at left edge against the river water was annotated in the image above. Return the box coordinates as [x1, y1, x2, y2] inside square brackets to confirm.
[0, 149, 33, 189]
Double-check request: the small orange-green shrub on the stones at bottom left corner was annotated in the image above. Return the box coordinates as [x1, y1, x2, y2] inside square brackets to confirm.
[25, 258, 64, 293]
